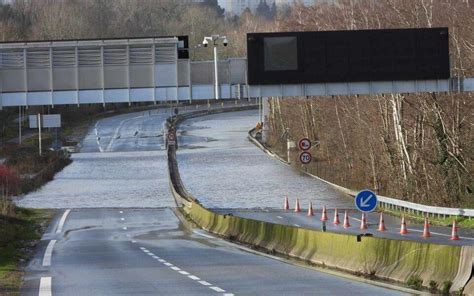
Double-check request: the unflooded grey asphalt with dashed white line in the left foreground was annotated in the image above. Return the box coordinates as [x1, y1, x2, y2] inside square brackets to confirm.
[22, 208, 408, 296]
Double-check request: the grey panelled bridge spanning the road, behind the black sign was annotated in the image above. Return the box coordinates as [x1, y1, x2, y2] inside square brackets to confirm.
[0, 30, 474, 108]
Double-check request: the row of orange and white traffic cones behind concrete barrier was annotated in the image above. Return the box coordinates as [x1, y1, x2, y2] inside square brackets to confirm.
[284, 196, 459, 240]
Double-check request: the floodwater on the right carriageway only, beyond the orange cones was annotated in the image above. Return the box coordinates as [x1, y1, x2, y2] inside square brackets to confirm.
[178, 110, 353, 208]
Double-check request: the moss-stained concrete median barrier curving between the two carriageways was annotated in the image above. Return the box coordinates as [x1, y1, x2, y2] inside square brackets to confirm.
[168, 107, 472, 288]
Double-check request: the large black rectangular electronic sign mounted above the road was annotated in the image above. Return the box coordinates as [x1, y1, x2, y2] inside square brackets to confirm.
[247, 28, 450, 85]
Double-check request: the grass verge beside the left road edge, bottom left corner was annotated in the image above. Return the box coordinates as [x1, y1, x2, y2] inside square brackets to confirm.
[0, 208, 54, 295]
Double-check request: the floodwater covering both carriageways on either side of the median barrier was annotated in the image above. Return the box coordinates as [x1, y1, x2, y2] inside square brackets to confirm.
[17, 110, 353, 208]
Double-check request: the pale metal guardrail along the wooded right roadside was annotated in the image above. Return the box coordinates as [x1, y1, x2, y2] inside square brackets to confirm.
[248, 128, 474, 220]
